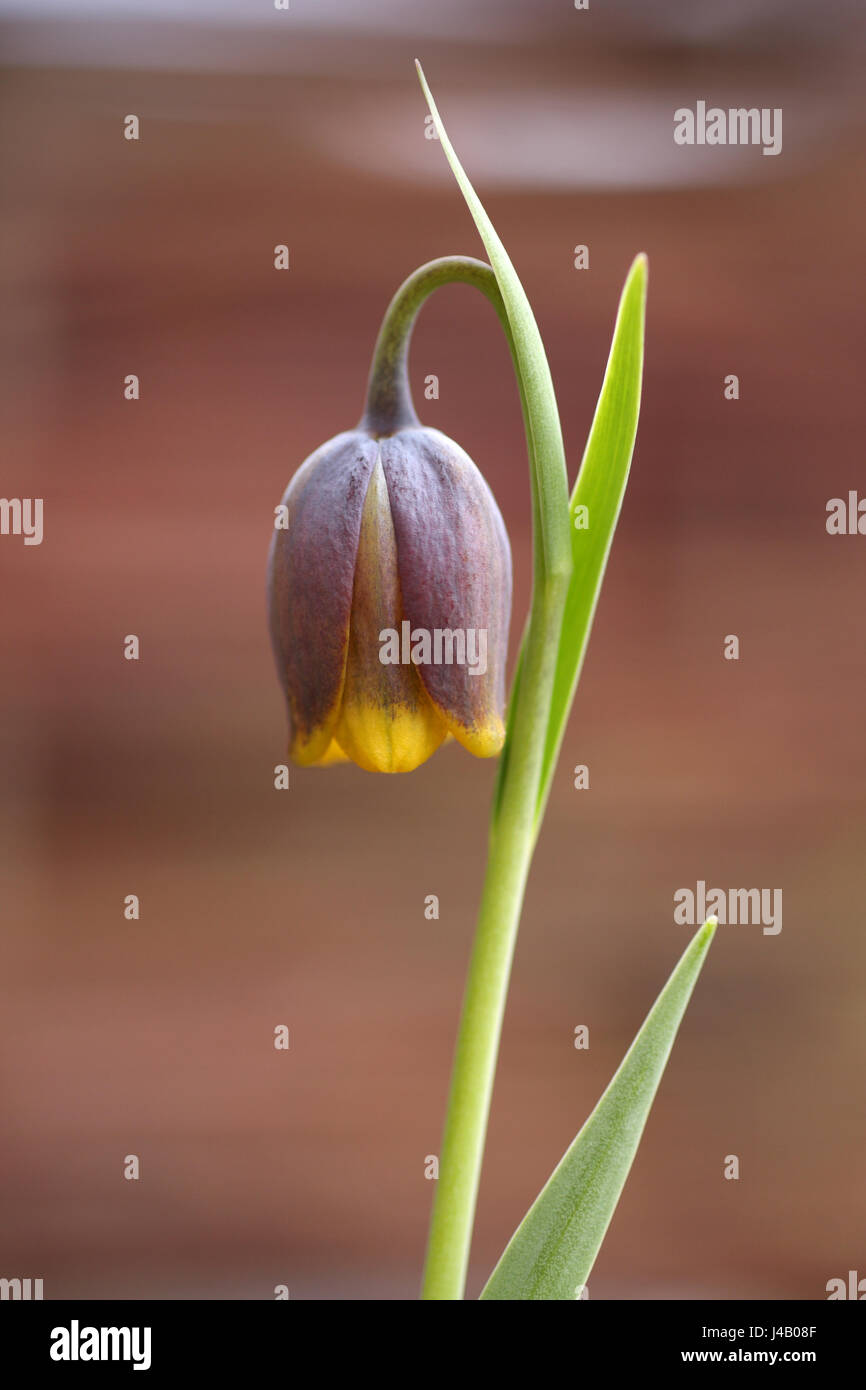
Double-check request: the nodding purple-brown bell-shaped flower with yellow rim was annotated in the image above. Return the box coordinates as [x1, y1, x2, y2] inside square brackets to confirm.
[268, 421, 512, 773]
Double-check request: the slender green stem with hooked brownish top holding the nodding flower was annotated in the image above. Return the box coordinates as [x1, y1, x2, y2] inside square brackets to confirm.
[360, 256, 571, 1300]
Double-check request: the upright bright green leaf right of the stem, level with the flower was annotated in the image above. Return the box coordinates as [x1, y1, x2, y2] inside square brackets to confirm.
[537, 256, 646, 820]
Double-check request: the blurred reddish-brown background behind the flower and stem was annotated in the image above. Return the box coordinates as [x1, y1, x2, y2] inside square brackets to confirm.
[0, 0, 866, 1300]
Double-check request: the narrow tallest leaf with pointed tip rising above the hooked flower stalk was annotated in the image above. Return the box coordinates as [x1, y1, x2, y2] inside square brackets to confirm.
[416, 61, 571, 577]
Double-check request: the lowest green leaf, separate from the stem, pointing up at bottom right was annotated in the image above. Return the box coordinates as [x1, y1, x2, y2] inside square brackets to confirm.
[481, 917, 716, 1301]
